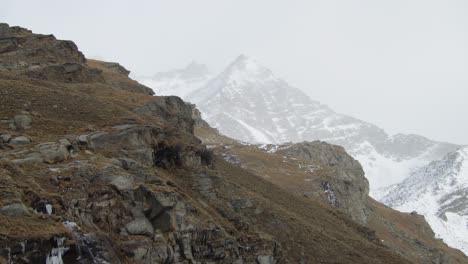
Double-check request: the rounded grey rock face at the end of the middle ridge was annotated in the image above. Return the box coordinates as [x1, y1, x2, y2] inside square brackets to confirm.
[280, 141, 369, 224]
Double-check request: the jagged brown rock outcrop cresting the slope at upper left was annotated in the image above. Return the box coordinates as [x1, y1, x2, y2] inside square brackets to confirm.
[0, 23, 154, 95]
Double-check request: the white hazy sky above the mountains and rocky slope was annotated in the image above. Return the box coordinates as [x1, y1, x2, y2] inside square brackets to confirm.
[0, 0, 468, 144]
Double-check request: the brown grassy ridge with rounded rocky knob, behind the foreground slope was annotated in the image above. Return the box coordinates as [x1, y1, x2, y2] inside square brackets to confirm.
[195, 124, 468, 263]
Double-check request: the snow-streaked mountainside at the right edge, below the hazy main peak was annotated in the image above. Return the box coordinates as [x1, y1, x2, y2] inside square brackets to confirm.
[381, 147, 468, 254]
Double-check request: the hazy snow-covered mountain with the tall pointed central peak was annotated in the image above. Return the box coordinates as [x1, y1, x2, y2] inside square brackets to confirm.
[179, 56, 457, 193]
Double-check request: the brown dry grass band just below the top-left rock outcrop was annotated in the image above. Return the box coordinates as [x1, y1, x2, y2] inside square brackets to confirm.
[0, 70, 152, 141]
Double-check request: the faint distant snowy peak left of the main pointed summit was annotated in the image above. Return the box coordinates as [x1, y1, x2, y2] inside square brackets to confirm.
[137, 62, 212, 98]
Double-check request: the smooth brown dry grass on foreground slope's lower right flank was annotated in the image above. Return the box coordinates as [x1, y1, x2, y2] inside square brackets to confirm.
[216, 161, 407, 263]
